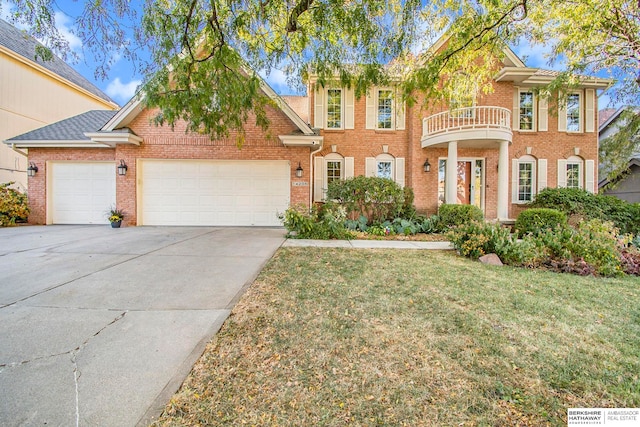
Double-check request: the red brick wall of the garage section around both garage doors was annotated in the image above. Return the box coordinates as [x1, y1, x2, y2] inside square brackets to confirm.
[29, 105, 311, 225]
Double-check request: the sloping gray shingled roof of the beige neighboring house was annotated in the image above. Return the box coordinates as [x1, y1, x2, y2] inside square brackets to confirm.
[0, 19, 116, 104]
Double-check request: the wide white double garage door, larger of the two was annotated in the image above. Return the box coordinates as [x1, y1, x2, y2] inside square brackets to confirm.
[138, 160, 290, 226]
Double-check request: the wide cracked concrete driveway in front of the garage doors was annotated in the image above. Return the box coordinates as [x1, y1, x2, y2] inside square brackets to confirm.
[0, 226, 285, 427]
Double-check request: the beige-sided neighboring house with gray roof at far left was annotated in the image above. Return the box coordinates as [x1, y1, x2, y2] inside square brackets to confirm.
[0, 20, 118, 190]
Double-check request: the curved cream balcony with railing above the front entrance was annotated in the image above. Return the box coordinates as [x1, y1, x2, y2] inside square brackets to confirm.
[421, 106, 513, 148]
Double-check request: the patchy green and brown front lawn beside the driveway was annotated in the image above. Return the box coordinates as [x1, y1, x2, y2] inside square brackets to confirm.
[157, 248, 640, 426]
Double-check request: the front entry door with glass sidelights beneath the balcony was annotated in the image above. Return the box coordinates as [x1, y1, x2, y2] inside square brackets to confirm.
[438, 159, 484, 209]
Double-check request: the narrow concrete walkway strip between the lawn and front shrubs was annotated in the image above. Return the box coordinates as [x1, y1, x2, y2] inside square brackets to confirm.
[282, 239, 453, 250]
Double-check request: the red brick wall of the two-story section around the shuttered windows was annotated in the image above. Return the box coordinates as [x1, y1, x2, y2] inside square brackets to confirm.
[309, 82, 598, 218]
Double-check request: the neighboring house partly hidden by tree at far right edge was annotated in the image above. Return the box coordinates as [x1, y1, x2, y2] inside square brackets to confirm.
[598, 107, 640, 203]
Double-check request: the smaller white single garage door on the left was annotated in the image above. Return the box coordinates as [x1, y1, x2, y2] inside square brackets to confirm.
[49, 162, 116, 224]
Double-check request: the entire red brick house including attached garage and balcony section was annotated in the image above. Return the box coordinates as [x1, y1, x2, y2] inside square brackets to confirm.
[6, 36, 611, 226]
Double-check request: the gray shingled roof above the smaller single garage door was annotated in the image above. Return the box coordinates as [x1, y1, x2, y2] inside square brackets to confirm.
[7, 110, 117, 142]
